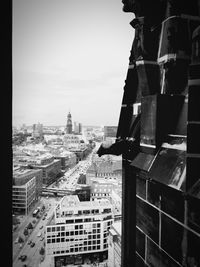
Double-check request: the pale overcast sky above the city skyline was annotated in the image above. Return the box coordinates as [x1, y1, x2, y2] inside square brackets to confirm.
[12, 0, 134, 126]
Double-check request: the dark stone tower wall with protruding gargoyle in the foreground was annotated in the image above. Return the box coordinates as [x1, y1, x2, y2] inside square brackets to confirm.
[97, 0, 200, 267]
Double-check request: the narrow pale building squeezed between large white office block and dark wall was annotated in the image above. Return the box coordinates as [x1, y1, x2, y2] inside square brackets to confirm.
[108, 221, 121, 267]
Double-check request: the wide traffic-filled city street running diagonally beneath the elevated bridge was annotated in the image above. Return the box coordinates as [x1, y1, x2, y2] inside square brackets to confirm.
[13, 150, 97, 267]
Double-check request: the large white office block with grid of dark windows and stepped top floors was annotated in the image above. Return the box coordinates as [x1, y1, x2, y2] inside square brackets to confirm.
[45, 195, 113, 266]
